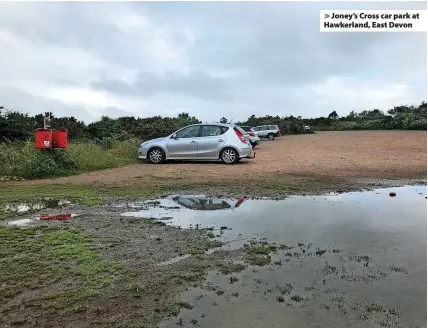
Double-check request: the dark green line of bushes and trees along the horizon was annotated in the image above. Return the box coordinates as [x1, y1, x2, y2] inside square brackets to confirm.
[0, 101, 427, 142]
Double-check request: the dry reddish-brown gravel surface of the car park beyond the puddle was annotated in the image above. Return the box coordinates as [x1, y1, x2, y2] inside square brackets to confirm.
[20, 131, 427, 186]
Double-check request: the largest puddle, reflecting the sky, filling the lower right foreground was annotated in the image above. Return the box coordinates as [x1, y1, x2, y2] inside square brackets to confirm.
[123, 186, 427, 328]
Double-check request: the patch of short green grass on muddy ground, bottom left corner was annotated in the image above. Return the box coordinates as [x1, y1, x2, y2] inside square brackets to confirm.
[0, 227, 123, 312]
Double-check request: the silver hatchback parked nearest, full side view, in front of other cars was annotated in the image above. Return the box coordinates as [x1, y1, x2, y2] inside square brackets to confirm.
[138, 123, 256, 164]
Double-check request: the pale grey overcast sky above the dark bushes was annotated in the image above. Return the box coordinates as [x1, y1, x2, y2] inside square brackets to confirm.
[0, 2, 427, 123]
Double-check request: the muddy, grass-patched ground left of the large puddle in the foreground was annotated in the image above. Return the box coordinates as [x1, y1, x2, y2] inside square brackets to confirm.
[0, 200, 274, 328]
